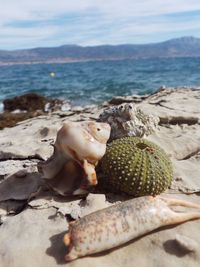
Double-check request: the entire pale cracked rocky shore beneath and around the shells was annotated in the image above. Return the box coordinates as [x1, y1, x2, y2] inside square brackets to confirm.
[0, 88, 200, 267]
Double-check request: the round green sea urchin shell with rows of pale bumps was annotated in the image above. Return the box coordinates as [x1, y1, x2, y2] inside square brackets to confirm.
[101, 137, 172, 196]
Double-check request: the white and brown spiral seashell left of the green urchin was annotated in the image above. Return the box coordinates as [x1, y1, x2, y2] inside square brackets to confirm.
[38, 121, 110, 195]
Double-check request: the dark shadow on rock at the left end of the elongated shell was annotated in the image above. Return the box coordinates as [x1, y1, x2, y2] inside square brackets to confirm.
[46, 232, 67, 265]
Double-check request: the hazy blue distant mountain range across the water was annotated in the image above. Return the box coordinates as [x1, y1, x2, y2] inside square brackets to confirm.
[0, 37, 200, 64]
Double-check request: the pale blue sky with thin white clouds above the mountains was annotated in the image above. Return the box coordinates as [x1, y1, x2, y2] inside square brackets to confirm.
[0, 0, 200, 50]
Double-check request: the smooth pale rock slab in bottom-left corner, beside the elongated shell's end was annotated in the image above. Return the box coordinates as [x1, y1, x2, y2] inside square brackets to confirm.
[0, 208, 68, 267]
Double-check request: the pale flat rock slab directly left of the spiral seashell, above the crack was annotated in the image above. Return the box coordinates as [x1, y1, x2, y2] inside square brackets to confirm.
[0, 117, 62, 160]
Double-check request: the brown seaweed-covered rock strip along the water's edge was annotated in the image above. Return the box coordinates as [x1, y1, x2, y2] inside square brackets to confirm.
[0, 86, 200, 130]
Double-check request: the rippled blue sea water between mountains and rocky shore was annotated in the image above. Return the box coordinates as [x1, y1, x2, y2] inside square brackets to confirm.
[0, 58, 200, 109]
